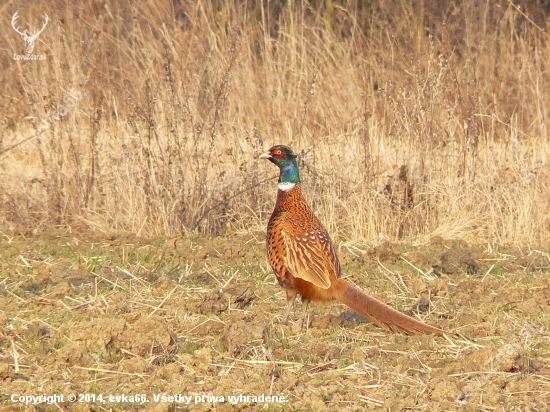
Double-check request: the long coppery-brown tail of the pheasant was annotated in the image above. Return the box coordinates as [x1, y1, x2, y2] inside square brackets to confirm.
[333, 279, 447, 335]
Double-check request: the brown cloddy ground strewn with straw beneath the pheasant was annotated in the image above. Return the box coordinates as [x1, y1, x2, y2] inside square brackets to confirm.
[0, 233, 550, 411]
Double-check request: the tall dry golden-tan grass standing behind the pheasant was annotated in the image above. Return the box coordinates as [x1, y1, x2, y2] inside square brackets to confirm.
[0, 0, 550, 244]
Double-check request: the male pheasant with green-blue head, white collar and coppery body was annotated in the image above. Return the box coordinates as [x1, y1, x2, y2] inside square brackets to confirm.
[260, 146, 446, 335]
